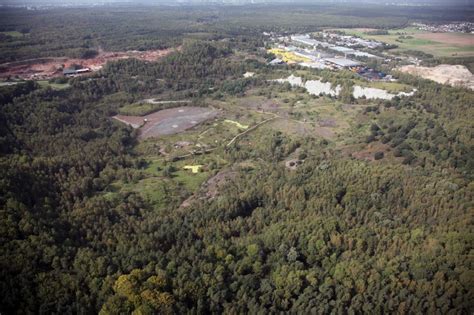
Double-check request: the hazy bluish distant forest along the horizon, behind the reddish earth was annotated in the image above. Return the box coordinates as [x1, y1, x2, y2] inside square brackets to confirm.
[0, 5, 473, 63]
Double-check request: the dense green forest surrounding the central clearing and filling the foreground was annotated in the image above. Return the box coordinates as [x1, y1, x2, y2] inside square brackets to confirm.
[0, 3, 474, 314]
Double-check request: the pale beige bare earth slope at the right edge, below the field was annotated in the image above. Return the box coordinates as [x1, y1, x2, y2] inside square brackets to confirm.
[397, 65, 474, 90]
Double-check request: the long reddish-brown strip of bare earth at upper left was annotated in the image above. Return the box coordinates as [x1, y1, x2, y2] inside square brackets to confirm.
[0, 49, 174, 80]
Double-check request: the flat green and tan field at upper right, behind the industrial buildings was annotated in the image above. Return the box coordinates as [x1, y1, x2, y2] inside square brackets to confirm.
[338, 27, 474, 57]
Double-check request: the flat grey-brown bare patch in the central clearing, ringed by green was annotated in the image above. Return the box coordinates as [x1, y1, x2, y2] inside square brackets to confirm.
[113, 107, 218, 139]
